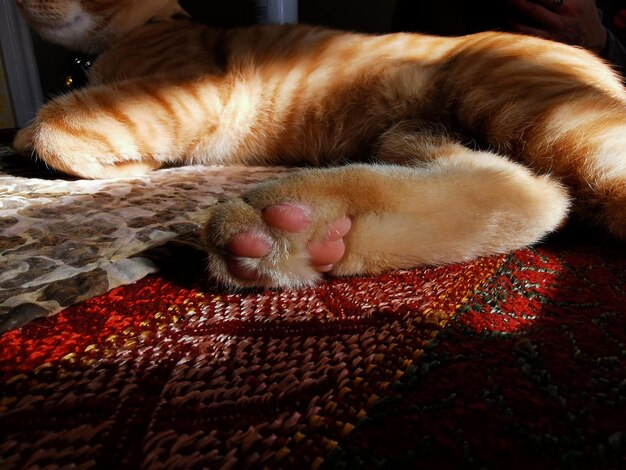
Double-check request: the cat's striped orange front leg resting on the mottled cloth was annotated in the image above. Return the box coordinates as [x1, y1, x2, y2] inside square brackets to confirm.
[14, 78, 216, 178]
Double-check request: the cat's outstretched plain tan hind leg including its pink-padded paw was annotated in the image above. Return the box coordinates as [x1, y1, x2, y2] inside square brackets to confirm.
[203, 151, 569, 287]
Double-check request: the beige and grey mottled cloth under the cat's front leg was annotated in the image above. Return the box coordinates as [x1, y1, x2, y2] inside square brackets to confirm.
[0, 145, 285, 332]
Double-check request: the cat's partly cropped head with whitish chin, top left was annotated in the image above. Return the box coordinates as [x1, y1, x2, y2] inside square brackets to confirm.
[16, 0, 185, 52]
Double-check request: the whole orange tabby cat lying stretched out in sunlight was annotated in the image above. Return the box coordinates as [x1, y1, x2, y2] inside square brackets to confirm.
[14, 0, 626, 287]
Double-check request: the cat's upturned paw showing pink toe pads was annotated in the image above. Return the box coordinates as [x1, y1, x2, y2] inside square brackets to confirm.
[204, 199, 351, 288]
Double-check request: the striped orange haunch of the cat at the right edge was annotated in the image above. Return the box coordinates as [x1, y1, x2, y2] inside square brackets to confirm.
[448, 33, 626, 239]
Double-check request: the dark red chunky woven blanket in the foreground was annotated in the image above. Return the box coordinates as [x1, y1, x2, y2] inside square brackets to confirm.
[0, 227, 626, 469]
